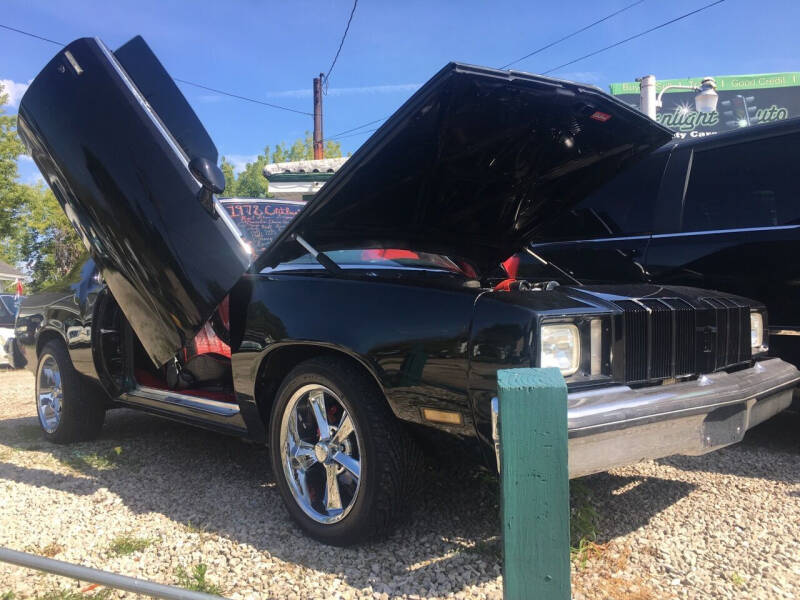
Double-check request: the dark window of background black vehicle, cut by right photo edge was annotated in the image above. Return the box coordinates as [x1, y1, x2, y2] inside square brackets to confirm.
[683, 134, 800, 231]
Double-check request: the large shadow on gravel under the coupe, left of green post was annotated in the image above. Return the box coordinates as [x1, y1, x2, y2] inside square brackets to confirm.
[0, 409, 501, 596]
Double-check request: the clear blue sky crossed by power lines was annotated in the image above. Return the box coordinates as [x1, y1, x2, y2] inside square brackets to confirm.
[0, 0, 800, 181]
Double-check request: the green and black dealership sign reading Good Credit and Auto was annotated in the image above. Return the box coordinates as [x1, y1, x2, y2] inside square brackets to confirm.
[611, 72, 800, 138]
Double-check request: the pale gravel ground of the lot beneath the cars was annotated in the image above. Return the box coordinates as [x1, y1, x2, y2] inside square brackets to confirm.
[0, 372, 800, 600]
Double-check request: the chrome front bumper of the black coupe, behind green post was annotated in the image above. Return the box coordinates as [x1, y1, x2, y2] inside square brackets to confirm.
[491, 358, 800, 478]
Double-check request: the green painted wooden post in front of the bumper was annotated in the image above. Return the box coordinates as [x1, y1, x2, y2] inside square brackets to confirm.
[497, 368, 571, 600]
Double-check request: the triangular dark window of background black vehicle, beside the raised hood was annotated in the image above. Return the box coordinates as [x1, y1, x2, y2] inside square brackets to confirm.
[537, 152, 668, 241]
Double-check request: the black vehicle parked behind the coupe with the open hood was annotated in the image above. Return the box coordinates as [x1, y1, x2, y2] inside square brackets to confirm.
[520, 119, 800, 365]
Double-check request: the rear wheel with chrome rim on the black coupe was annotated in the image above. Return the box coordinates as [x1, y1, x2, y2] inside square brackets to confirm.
[36, 340, 106, 444]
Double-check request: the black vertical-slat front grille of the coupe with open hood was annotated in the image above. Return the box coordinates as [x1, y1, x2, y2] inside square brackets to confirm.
[615, 298, 751, 383]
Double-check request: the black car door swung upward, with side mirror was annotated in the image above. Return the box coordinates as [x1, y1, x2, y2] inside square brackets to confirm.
[18, 37, 251, 366]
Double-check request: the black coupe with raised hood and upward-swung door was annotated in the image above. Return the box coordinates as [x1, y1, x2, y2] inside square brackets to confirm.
[15, 38, 800, 544]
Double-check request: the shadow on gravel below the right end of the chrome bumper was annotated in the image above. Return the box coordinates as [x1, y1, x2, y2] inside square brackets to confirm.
[658, 412, 800, 484]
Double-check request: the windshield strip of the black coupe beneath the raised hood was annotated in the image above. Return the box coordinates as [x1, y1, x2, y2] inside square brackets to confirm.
[276, 248, 474, 277]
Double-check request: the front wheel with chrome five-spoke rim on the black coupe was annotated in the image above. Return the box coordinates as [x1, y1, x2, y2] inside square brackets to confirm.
[270, 357, 422, 546]
